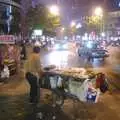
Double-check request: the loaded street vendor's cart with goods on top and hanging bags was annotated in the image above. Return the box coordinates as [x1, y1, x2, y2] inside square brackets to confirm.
[41, 68, 99, 106]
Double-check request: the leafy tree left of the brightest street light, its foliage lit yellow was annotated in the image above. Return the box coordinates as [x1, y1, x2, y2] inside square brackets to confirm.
[26, 4, 60, 34]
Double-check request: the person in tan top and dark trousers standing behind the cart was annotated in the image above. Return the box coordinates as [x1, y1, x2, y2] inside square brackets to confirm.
[25, 46, 42, 103]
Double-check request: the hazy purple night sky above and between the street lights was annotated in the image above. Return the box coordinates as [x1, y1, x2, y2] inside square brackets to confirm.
[32, 0, 120, 24]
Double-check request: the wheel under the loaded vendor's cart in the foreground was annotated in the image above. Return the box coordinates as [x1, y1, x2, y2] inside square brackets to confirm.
[52, 92, 64, 107]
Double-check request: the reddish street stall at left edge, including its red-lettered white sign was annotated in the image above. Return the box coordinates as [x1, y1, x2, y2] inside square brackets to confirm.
[0, 35, 19, 75]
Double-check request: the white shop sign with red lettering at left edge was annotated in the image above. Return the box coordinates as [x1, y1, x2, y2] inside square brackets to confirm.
[0, 35, 15, 44]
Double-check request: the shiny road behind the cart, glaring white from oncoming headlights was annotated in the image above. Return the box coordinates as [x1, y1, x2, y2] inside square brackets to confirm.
[41, 42, 120, 72]
